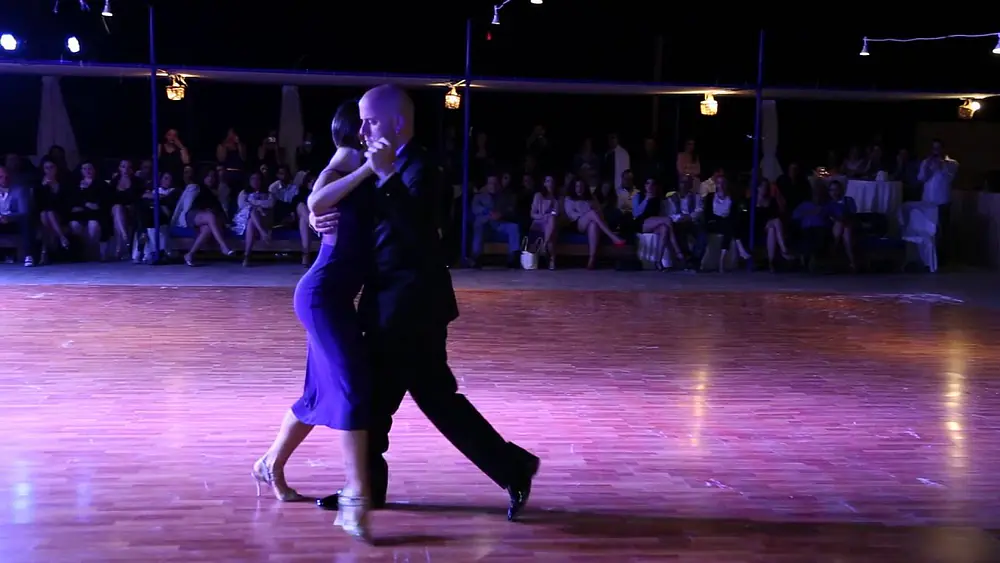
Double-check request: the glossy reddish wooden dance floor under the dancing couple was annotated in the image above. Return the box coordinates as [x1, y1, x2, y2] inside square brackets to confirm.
[0, 285, 1000, 563]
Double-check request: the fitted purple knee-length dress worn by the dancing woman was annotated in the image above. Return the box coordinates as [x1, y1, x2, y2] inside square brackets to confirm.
[292, 177, 374, 430]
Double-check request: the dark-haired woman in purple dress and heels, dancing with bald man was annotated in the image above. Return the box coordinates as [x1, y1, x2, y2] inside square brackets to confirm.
[252, 102, 374, 539]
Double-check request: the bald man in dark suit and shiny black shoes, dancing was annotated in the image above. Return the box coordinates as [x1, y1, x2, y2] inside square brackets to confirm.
[310, 85, 539, 520]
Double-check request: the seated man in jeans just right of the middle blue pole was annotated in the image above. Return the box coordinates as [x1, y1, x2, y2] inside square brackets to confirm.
[472, 176, 521, 267]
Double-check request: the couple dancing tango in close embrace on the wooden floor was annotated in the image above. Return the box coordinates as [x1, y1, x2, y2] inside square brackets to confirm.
[252, 85, 539, 541]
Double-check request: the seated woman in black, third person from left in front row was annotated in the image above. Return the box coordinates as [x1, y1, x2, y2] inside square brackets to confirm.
[69, 162, 111, 262]
